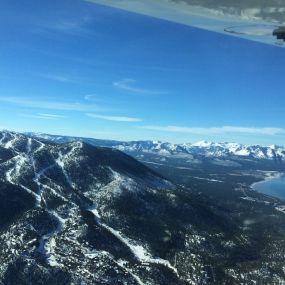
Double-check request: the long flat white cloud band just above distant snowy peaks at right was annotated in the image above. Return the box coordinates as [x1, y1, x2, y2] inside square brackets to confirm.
[141, 125, 285, 136]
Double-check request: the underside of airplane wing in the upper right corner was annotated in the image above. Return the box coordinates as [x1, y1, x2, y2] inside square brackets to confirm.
[87, 0, 285, 47]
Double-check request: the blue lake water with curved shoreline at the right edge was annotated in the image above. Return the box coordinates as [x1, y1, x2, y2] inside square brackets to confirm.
[253, 176, 285, 200]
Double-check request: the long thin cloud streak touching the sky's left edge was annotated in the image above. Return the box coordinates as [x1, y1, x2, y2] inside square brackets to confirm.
[0, 96, 102, 112]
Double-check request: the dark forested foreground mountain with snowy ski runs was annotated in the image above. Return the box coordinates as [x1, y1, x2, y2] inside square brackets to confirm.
[0, 131, 285, 285]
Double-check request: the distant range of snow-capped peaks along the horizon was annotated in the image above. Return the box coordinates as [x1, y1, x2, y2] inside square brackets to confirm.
[26, 133, 285, 160]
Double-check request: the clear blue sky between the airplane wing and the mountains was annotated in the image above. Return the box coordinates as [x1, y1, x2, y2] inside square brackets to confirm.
[0, 0, 285, 145]
